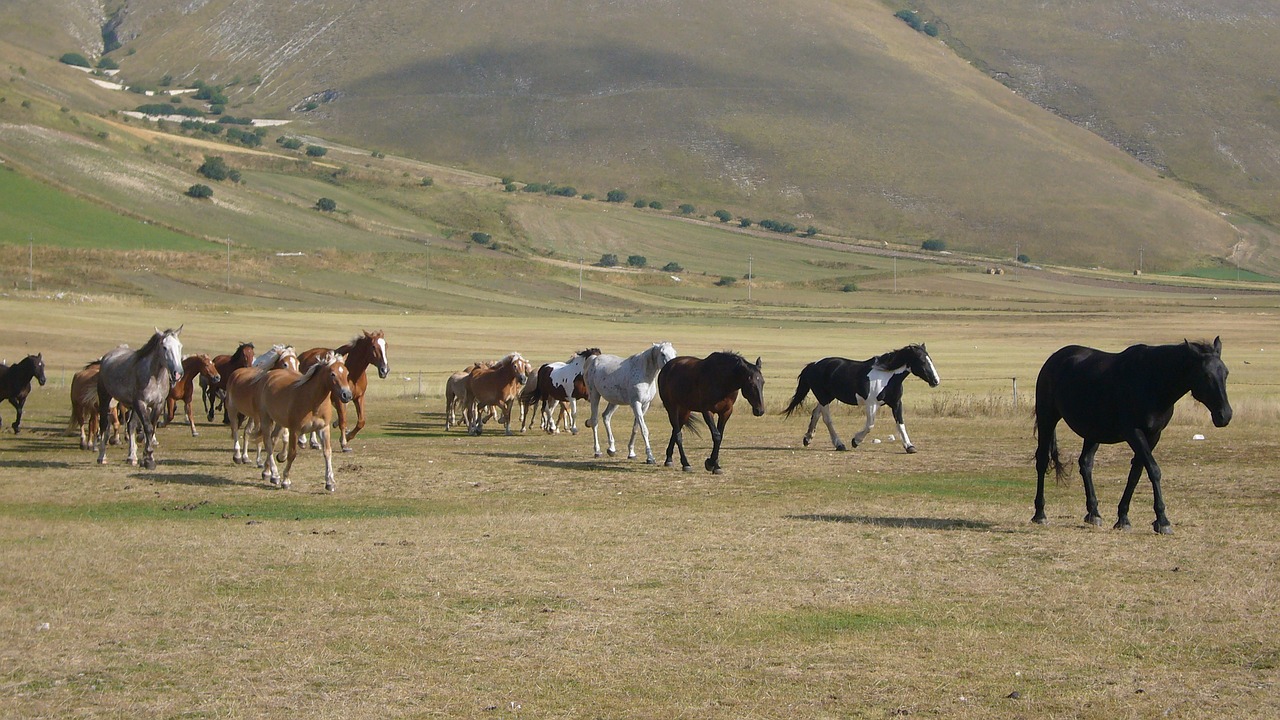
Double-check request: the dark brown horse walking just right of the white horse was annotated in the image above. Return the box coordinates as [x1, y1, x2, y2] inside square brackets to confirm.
[658, 352, 764, 475]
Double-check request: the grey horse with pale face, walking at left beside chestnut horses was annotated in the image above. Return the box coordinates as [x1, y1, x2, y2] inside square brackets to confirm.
[97, 327, 182, 470]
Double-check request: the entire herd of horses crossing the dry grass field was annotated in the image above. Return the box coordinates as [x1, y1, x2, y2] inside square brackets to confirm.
[0, 327, 1231, 533]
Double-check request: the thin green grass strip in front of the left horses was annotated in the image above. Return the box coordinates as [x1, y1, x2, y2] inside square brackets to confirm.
[0, 498, 424, 521]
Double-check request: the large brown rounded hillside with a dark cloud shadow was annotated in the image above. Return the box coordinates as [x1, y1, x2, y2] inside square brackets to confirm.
[3, 0, 1276, 270]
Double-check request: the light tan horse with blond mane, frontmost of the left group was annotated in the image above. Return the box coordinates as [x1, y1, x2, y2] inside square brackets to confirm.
[257, 351, 355, 492]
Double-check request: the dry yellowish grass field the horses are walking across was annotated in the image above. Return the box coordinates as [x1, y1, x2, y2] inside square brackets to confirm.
[0, 288, 1280, 719]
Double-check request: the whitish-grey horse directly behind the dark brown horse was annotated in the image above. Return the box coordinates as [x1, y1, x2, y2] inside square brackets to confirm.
[582, 342, 676, 465]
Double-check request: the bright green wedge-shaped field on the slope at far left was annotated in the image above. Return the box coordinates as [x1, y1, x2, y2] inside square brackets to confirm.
[0, 169, 215, 252]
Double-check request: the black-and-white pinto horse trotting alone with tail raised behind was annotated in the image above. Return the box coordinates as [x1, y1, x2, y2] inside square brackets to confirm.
[782, 345, 942, 452]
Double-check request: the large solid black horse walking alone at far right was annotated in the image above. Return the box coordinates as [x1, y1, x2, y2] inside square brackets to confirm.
[1032, 338, 1231, 533]
